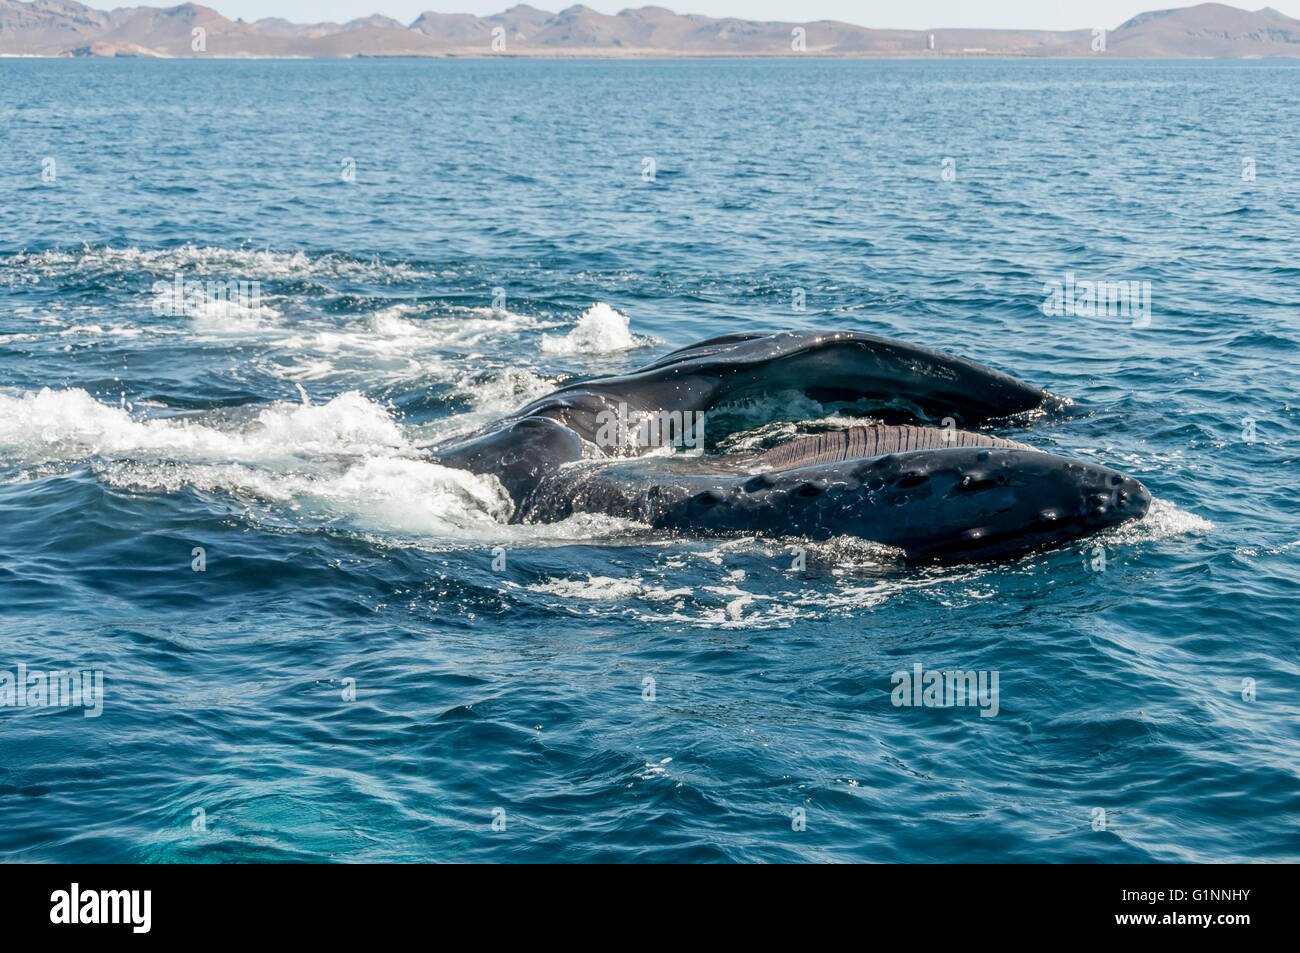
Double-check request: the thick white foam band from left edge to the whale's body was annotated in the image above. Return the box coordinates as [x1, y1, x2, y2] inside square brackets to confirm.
[0, 389, 530, 540]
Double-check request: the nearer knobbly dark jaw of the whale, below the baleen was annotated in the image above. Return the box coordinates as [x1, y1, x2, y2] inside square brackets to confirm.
[521, 442, 1151, 562]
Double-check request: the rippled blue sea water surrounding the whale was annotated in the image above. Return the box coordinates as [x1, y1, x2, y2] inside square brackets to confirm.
[0, 59, 1300, 862]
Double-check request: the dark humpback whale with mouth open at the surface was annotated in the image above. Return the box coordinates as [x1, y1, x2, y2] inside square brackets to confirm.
[428, 332, 1151, 560]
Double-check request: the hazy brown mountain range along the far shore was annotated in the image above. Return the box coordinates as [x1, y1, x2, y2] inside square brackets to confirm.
[0, 0, 1300, 57]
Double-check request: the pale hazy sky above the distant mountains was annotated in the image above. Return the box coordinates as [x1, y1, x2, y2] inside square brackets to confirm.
[200, 0, 1300, 30]
